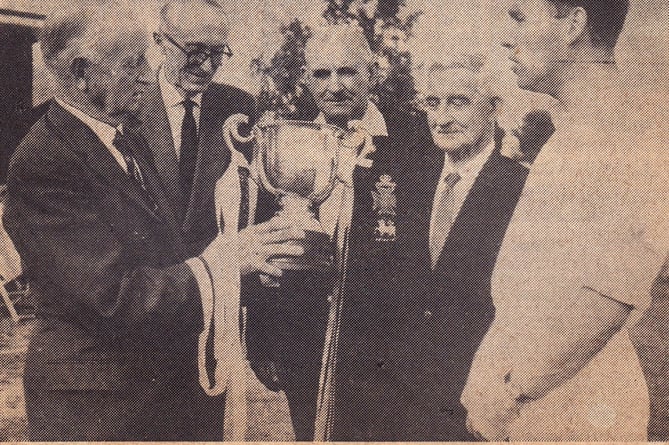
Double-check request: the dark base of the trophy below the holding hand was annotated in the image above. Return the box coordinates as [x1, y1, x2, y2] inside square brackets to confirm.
[268, 230, 334, 271]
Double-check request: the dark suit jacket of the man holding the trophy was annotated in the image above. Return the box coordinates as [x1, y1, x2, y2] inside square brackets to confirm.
[4, 104, 219, 440]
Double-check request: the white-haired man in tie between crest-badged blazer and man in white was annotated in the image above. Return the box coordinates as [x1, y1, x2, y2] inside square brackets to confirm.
[408, 55, 553, 440]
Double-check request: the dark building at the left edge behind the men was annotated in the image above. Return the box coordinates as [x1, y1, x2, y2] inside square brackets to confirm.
[0, 9, 46, 184]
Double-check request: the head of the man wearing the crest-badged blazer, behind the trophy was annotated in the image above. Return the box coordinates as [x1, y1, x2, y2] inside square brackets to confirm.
[304, 25, 376, 128]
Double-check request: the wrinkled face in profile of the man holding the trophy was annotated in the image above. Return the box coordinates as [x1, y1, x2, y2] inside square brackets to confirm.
[86, 32, 151, 125]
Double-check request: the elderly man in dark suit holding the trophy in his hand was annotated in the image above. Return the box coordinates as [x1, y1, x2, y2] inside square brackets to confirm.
[3, 1, 299, 441]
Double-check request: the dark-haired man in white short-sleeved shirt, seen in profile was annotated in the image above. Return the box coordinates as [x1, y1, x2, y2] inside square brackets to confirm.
[463, 0, 669, 441]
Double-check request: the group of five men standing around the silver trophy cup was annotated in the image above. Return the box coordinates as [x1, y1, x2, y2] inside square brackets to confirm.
[4, 0, 669, 441]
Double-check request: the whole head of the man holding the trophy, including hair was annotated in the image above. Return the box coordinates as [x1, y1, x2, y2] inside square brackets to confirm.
[40, 1, 149, 126]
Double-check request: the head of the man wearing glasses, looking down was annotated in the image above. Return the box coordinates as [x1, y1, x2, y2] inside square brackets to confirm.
[156, 0, 231, 95]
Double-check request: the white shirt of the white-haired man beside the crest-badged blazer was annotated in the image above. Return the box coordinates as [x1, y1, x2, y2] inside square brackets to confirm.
[430, 140, 495, 246]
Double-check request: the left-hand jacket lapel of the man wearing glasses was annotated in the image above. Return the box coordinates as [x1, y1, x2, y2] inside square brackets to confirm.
[141, 82, 184, 218]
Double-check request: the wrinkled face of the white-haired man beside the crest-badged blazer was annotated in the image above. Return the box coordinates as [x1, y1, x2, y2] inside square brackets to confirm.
[422, 68, 495, 154]
